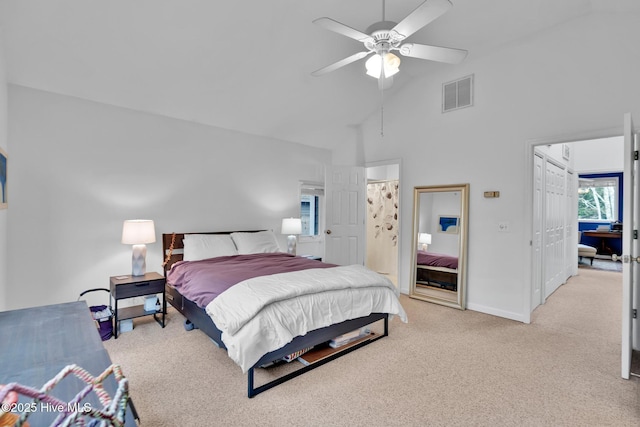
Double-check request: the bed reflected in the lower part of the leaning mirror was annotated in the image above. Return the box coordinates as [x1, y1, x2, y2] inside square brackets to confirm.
[416, 250, 458, 292]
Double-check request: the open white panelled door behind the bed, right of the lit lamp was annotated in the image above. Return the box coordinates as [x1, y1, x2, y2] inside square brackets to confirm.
[324, 166, 367, 265]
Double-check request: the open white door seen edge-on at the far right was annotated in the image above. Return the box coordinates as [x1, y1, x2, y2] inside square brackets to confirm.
[622, 113, 640, 379]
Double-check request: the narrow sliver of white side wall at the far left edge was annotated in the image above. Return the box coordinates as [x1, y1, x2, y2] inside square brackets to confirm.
[0, 28, 10, 311]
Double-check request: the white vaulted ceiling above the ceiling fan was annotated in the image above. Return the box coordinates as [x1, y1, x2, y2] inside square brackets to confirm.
[0, 0, 640, 148]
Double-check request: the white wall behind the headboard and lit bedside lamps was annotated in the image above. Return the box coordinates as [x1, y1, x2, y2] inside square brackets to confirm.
[7, 85, 331, 308]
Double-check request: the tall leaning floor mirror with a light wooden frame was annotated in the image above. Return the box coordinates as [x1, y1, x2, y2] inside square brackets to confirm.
[409, 184, 469, 310]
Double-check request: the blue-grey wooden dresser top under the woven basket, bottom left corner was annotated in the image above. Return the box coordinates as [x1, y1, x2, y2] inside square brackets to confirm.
[0, 301, 136, 426]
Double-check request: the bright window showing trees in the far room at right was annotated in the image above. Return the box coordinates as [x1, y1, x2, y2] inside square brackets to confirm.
[578, 176, 619, 222]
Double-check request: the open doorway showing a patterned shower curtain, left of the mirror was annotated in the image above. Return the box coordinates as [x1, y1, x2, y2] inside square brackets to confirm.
[365, 160, 400, 286]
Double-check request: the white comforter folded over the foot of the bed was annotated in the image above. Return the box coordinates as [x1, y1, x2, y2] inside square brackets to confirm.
[206, 265, 407, 372]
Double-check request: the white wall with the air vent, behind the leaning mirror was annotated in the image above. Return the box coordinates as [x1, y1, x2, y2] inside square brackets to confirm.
[350, 9, 640, 321]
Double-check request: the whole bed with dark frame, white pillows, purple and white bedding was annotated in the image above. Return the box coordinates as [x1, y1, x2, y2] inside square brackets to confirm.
[162, 230, 406, 398]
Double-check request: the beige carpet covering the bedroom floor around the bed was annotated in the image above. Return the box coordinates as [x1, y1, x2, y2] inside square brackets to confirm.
[105, 269, 640, 426]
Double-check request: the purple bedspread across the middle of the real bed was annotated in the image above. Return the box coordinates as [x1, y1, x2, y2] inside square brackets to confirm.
[167, 252, 335, 308]
